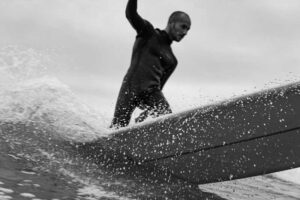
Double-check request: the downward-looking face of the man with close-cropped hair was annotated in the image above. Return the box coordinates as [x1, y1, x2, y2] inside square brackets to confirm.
[171, 19, 191, 42]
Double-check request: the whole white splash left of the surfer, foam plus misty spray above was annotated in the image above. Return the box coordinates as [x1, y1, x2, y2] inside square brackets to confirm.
[0, 46, 108, 141]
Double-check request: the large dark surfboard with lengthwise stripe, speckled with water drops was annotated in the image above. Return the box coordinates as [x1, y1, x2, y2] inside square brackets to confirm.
[79, 82, 300, 184]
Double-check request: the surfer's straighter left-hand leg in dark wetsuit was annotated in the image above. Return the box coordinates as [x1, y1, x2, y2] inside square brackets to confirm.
[110, 88, 136, 128]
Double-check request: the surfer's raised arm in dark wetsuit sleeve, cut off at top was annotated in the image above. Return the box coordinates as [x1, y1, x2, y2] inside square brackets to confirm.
[126, 0, 154, 35]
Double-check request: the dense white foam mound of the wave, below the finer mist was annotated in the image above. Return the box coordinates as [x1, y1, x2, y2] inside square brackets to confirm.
[0, 77, 107, 141]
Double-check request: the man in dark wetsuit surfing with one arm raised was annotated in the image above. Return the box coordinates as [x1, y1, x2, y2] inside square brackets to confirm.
[111, 0, 191, 128]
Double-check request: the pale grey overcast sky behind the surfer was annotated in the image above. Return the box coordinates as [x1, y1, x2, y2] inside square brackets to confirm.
[0, 0, 300, 108]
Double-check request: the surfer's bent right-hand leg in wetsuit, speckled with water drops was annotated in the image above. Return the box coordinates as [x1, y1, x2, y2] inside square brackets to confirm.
[135, 90, 172, 122]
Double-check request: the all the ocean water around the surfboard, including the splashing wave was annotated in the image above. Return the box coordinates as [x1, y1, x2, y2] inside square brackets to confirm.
[0, 46, 300, 200]
